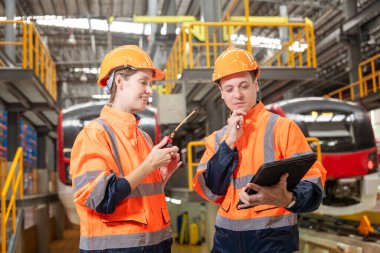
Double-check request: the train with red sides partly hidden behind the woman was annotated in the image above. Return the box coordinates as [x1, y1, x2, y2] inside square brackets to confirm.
[57, 101, 161, 224]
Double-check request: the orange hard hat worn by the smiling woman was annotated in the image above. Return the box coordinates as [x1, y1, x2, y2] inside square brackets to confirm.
[98, 45, 165, 87]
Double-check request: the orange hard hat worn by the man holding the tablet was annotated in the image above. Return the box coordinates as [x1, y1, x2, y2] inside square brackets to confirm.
[212, 47, 260, 82]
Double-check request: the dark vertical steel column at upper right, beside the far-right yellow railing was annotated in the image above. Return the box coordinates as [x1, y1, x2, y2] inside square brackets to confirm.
[343, 0, 361, 83]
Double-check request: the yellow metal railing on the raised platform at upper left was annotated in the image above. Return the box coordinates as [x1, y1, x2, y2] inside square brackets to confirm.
[0, 20, 57, 100]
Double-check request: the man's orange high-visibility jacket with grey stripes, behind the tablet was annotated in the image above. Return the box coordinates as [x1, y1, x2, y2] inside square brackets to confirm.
[193, 102, 326, 252]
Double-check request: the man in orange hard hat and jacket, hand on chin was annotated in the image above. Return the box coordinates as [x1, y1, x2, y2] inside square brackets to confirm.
[193, 48, 326, 253]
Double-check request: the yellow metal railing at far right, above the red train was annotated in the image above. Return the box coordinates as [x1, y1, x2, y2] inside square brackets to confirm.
[325, 54, 380, 101]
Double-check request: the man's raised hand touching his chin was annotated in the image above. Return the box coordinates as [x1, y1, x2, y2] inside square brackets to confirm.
[226, 110, 247, 149]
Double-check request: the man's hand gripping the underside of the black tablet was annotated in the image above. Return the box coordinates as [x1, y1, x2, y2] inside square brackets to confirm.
[238, 173, 293, 209]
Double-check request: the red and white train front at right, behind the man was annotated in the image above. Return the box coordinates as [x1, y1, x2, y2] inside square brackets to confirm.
[267, 97, 380, 215]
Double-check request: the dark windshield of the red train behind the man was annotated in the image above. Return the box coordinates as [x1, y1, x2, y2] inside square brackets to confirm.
[289, 111, 357, 152]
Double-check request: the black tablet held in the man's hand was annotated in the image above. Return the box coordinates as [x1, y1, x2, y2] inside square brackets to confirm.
[236, 153, 317, 208]
